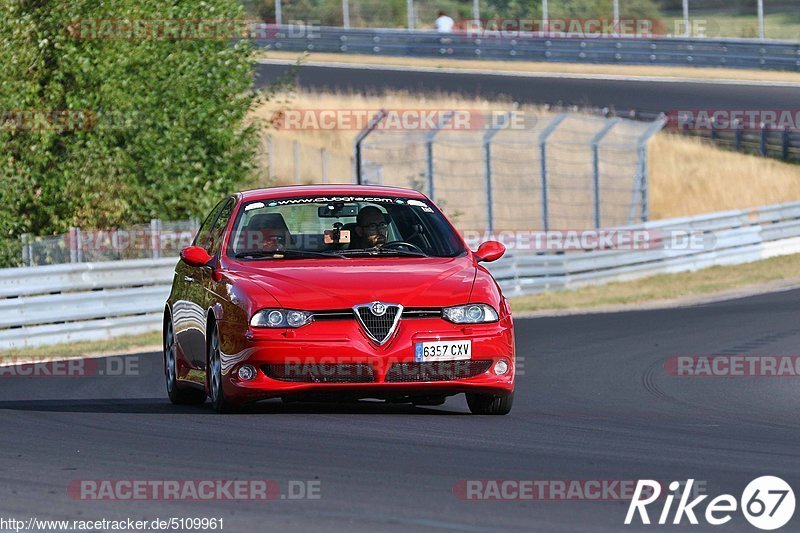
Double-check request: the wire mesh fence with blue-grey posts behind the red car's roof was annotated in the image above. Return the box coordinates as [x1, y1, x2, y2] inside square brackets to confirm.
[355, 113, 665, 231]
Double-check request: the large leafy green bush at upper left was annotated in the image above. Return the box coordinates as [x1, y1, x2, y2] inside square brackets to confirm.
[0, 0, 256, 266]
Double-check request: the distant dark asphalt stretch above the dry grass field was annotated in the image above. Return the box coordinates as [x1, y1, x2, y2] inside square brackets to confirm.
[255, 63, 800, 113]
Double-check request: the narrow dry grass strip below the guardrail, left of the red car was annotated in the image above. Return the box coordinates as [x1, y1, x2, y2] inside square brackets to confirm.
[0, 331, 161, 363]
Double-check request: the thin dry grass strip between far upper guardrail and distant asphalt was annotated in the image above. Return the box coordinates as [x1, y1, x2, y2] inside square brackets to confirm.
[260, 51, 800, 83]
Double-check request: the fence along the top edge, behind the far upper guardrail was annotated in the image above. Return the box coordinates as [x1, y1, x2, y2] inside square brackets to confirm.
[243, 0, 800, 41]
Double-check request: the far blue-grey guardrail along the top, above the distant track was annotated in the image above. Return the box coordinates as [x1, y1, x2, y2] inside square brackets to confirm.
[256, 25, 800, 71]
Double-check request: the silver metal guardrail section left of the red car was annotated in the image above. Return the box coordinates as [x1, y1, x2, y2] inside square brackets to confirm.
[0, 257, 177, 349]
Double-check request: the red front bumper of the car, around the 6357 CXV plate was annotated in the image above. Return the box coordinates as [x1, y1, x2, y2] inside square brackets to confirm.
[220, 317, 515, 402]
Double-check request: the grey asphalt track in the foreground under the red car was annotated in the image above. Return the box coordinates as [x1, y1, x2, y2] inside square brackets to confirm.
[0, 291, 800, 532]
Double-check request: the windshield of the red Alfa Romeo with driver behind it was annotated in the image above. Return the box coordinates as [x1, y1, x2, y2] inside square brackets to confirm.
[227, 197, 466, 260]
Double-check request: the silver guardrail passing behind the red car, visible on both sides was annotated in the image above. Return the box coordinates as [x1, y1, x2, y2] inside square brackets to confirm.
[0, 202, 800, 349]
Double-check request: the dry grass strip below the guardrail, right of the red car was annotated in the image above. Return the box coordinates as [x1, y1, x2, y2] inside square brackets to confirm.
[510, 255, 800, 312]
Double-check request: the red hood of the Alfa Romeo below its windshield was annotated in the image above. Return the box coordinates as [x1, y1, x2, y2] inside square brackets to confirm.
[237, 256, 477, 311]
